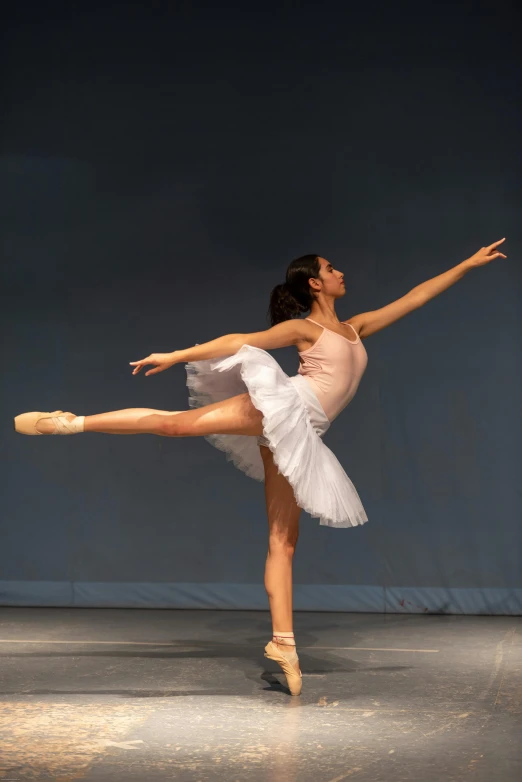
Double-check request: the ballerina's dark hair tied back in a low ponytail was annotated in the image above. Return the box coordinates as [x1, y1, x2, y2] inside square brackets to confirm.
[268, 255, 321, 326]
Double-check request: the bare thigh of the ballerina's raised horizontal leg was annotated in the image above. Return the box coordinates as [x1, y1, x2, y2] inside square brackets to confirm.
[166, 393, 263, 437]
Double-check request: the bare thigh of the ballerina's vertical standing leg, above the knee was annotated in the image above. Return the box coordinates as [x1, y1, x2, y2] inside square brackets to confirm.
[259, 445, 301, 546]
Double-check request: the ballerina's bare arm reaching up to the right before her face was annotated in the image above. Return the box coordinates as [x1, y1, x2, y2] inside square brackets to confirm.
[349, 239, 506, 339]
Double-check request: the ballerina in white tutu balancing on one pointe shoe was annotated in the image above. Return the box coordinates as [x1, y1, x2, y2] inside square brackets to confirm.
[15, 239, 506, 695]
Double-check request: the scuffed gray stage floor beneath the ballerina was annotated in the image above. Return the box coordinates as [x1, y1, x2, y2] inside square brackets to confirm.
[0, 608, 522, 782]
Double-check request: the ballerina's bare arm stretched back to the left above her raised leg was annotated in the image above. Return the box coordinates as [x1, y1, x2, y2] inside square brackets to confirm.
[131, 319, 308, 375]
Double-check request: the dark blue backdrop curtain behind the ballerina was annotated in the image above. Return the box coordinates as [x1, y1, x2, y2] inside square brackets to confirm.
[0, 1, 522, 614]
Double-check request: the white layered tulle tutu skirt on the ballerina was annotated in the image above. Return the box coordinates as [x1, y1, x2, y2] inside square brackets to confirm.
[186, 345, 368, 527]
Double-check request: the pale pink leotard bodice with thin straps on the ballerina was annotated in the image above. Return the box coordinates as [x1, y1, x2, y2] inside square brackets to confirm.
[298, 318, 368, 421]
